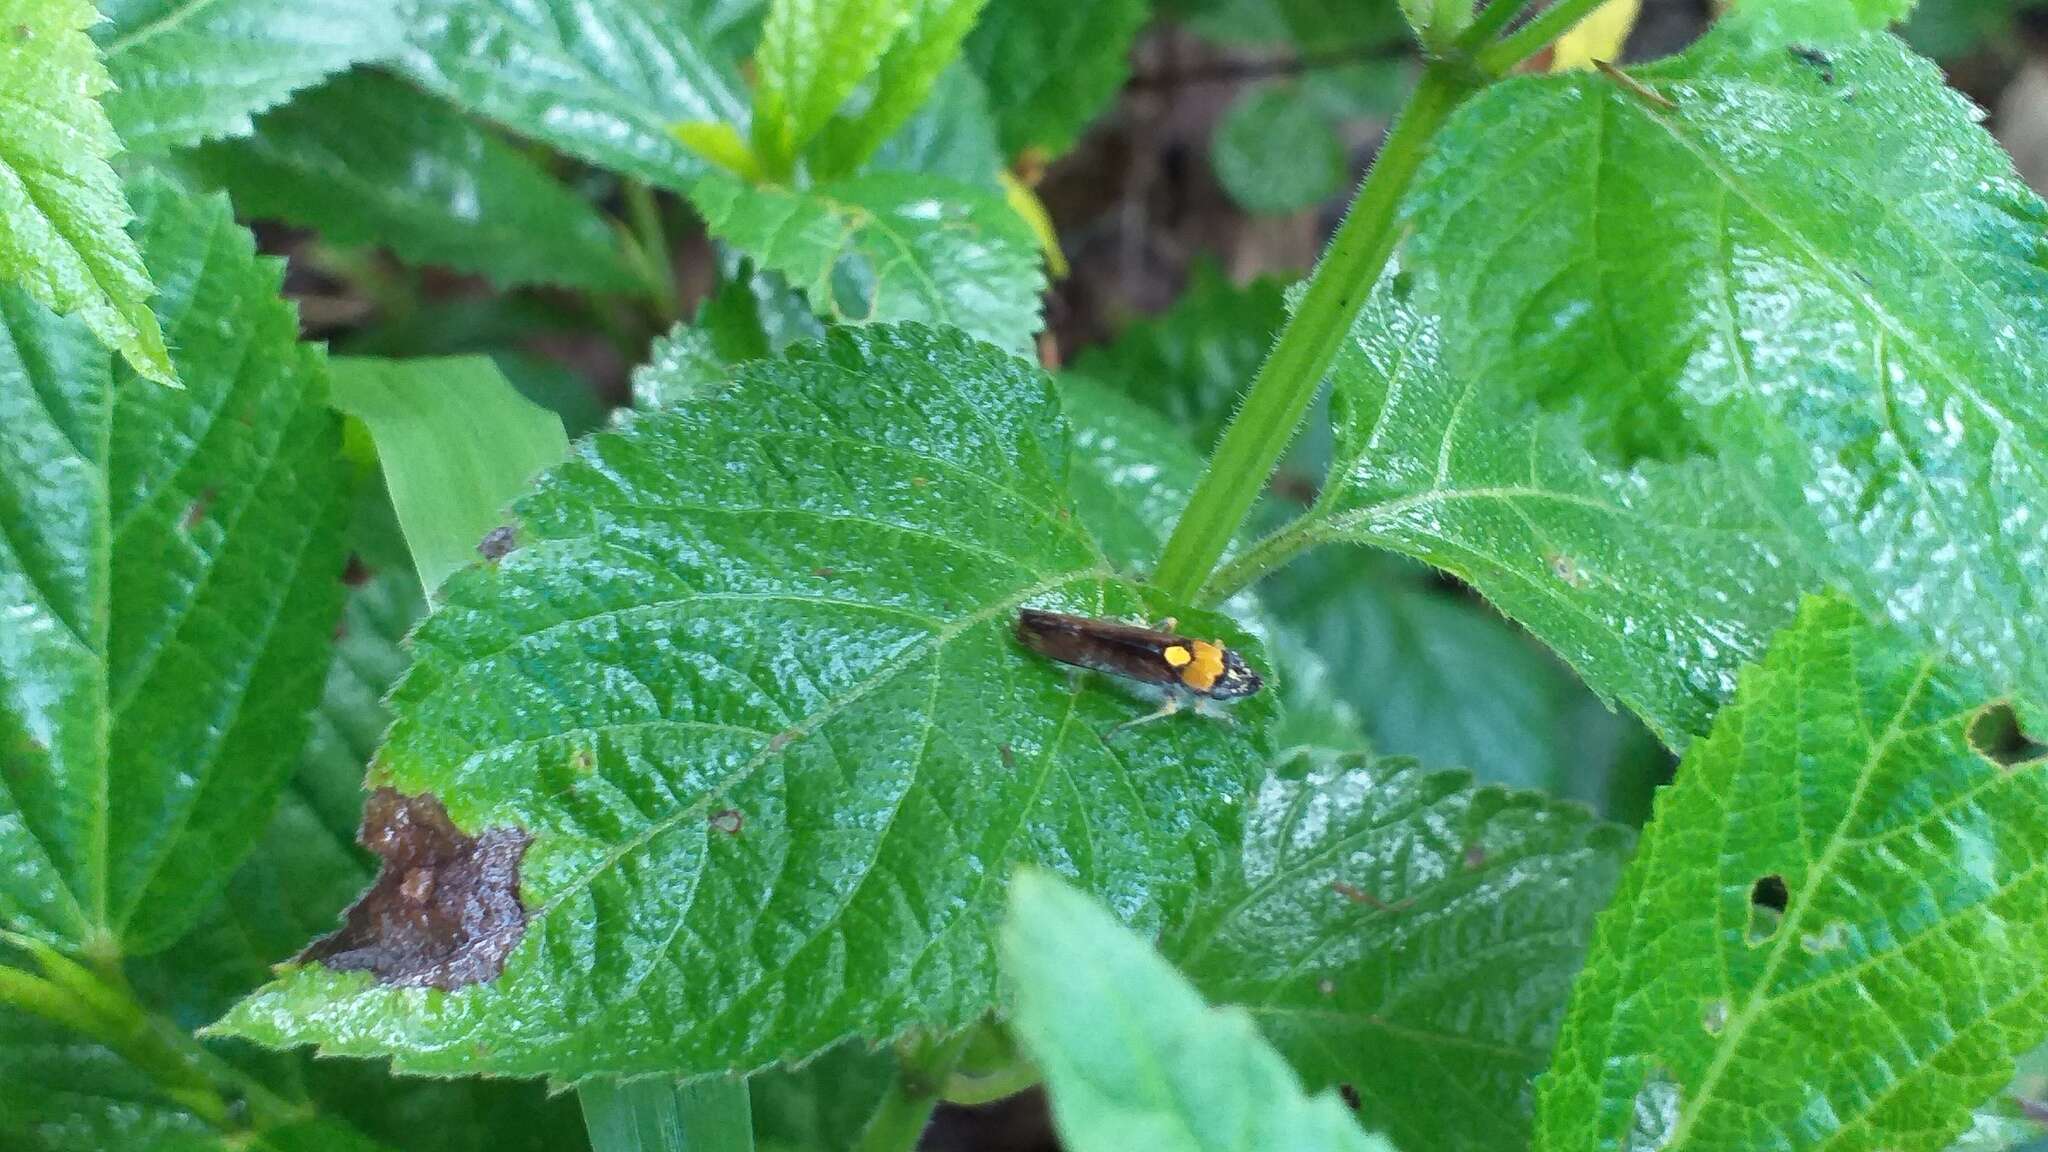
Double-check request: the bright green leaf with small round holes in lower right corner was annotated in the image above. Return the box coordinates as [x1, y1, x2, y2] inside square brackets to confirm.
[1538, 601, 2048, 1152]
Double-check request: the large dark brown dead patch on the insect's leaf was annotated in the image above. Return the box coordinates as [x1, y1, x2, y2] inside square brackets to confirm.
[299, 787, 532, 992]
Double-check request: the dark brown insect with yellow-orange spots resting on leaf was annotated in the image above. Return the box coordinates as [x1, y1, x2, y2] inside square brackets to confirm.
[1018, 609, 1264, 738]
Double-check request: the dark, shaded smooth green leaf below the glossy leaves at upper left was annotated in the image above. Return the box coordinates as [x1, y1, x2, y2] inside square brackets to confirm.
[195, 72, 637, 291]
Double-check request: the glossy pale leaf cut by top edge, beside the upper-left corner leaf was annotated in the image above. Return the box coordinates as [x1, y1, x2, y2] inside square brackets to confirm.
[94, 0, 403, 152]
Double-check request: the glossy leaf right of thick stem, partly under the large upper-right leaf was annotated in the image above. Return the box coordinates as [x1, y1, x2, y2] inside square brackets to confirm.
[1269, 275, 1810, 748]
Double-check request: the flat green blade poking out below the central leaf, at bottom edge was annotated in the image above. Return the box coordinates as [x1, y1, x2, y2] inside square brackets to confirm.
[575, 1078, 754, 1152]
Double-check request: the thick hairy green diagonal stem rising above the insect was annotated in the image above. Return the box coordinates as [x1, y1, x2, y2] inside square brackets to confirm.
[1153, 61, 1482, 601]
